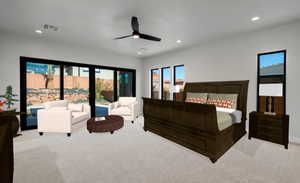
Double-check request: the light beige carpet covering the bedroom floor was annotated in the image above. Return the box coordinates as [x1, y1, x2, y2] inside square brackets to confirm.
[14, 118, 300, 183]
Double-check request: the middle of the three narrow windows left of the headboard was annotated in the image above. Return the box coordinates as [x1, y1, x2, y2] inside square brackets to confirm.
[161, 67, 171, 100]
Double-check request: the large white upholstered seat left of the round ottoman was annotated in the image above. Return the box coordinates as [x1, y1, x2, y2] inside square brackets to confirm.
[37, 100, 91, 136]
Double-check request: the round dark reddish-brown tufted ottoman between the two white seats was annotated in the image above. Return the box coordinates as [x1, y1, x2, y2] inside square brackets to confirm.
[87, 115, 124, 134]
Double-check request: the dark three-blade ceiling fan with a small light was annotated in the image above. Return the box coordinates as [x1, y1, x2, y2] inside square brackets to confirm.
[115, 17, 161, 41]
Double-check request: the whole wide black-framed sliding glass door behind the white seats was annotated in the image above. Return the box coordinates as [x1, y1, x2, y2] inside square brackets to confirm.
[20, 57, 136, 130]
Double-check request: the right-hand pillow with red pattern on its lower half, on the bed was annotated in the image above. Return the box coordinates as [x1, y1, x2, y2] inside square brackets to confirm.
[207, 93, 238, 109]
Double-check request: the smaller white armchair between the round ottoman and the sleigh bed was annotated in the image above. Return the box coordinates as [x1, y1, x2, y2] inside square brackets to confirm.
[108, 97, 138, 123]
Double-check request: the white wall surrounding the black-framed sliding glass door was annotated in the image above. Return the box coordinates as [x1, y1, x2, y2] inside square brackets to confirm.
[0, 33, 143, 113]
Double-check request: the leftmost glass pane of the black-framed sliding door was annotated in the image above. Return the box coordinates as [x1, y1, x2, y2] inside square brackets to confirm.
[25, 62, 60, 128]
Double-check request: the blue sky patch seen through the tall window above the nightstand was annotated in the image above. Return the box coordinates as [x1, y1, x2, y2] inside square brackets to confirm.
[260, 52, 284, 68]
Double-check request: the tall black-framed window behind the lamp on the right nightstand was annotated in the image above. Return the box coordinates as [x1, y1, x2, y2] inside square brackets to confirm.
[257, 50, 286, 114]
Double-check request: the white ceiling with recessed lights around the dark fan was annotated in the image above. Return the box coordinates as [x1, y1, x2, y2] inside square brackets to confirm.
[0, 0, 300, 57]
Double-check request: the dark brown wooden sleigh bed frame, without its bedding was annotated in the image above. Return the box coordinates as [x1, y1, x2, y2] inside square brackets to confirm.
[143, 81, 249, 163]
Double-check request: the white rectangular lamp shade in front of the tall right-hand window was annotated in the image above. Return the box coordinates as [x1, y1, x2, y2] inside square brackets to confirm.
[259, 83, 283, 97]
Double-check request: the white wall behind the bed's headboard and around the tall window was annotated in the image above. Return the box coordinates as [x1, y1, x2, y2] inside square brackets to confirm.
[143, 22, 300, 142]
